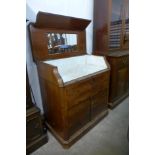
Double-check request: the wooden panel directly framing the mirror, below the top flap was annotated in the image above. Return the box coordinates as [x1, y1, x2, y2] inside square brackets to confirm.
[29, 24, 86, 62]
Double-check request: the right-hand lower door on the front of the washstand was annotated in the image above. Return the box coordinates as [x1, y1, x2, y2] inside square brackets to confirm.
[91, 90, 108, 119]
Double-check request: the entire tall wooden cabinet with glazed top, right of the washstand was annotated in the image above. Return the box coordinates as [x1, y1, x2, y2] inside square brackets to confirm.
[93, 0, 129, 107]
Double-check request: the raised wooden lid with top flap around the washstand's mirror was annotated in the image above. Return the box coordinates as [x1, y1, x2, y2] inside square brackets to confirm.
[29, 12, 90, 61]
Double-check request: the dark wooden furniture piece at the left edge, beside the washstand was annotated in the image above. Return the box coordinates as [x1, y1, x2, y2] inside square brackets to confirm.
[26, 72, 47, 154]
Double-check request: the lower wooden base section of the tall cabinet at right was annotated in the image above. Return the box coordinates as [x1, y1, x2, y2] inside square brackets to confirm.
[107, 51, 129, 108]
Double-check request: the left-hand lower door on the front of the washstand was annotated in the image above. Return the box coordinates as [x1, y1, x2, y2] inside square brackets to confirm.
[68, 99, 91, 136]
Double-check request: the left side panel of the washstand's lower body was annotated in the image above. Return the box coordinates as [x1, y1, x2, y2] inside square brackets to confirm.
[40, 78, 65, 138]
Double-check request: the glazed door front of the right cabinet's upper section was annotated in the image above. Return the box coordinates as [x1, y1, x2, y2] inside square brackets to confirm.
[109, 0, 129, 50]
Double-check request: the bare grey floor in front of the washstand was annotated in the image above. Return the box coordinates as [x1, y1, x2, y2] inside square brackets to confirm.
[31, 98, 129, 155]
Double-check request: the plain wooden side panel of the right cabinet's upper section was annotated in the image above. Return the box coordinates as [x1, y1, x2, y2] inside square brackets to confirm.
[93, 0, 110, 52]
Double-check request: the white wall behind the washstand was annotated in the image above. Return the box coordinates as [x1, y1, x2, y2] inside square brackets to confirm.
[26, 0, 93, 112]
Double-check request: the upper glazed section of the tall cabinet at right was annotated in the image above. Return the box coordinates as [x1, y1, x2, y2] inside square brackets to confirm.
[93, 0, 129, 55]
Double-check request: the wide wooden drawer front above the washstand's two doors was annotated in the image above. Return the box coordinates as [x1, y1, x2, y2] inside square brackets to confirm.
[66, 72, 109, 109]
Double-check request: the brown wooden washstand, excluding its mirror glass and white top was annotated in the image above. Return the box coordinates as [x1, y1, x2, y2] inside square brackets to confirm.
[29, 12, 110, 148]
